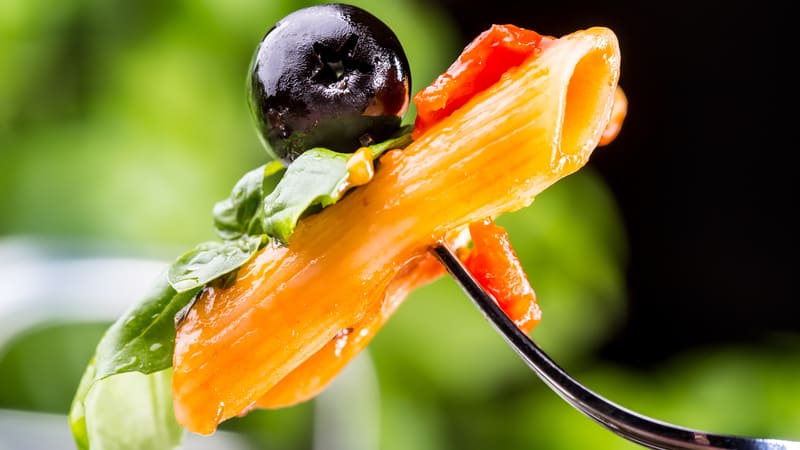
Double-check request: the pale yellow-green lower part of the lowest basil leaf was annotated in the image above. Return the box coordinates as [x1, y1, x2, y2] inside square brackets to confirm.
[69, 363, 183, 450]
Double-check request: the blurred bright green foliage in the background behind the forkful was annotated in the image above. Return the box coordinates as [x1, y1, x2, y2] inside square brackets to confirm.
[0, 0, 800, 450]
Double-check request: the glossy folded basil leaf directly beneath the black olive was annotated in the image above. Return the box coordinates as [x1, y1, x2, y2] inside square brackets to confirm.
[263, 128, 411, 244]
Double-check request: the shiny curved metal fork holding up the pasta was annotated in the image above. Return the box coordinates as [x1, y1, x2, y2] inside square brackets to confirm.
[432, 244, 800, 450]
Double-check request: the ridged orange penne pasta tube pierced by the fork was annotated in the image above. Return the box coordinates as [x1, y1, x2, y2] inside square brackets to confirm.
[173, 27, 620, 434]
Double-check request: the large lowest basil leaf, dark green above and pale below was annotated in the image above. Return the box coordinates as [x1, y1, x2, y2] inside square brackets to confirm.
[69, 270, 200, 450]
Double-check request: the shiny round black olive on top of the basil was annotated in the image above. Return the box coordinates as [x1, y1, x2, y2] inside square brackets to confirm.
[249, 3, 411, 164]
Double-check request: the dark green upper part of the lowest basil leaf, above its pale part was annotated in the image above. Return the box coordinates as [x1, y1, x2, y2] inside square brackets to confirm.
[94, 271, 200, 380]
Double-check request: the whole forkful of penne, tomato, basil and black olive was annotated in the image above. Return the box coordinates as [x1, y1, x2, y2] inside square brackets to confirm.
[71, 4, 625, 448]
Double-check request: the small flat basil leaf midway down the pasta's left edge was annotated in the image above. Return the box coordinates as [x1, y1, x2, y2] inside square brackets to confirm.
[169, 235, 265, 292]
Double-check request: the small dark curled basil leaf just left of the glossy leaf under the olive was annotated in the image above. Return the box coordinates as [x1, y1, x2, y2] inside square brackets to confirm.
[213, 161, 285, 240]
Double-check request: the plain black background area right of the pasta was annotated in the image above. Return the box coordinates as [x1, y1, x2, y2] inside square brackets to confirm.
[440, 0, 800, 366]
